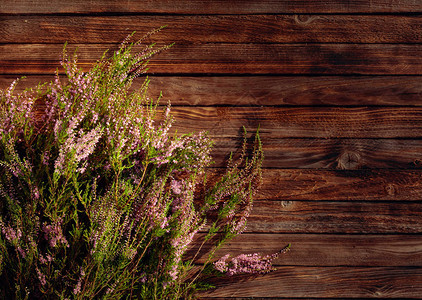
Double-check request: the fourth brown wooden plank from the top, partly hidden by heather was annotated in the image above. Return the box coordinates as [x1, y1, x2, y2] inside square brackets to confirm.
[0, 75, 422, 106]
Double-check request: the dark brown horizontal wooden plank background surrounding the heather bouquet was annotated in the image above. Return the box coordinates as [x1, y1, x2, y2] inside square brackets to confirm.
[0, 0, 422, 299]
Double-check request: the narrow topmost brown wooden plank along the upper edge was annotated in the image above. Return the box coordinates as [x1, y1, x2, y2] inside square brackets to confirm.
[0, 0, 422, 14]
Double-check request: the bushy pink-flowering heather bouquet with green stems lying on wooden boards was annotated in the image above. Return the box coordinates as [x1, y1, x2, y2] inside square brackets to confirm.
[0, 31, 286, 299]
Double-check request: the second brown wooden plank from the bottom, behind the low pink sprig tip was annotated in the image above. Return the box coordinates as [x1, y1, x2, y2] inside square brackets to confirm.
[191, 233, 422, 267]
